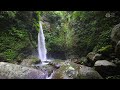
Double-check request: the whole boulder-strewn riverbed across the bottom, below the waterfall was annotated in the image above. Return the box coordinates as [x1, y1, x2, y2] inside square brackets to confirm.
[0, 53, 119, 79]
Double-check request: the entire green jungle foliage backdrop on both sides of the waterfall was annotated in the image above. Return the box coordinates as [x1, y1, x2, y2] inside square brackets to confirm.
[0, 11, 120, 60]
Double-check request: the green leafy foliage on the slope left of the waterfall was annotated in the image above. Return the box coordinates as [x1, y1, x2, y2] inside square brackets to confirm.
[0, 11, 40, 62]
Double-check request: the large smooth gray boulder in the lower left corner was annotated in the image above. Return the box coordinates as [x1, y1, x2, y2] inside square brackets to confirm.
[0, 62, 46, 79]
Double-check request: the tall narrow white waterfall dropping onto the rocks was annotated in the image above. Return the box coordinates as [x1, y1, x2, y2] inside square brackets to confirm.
[38, 22, 47, 61]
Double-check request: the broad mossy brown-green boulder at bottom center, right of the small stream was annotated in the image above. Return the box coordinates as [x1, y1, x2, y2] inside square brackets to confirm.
[52, 61, 102, 79]
